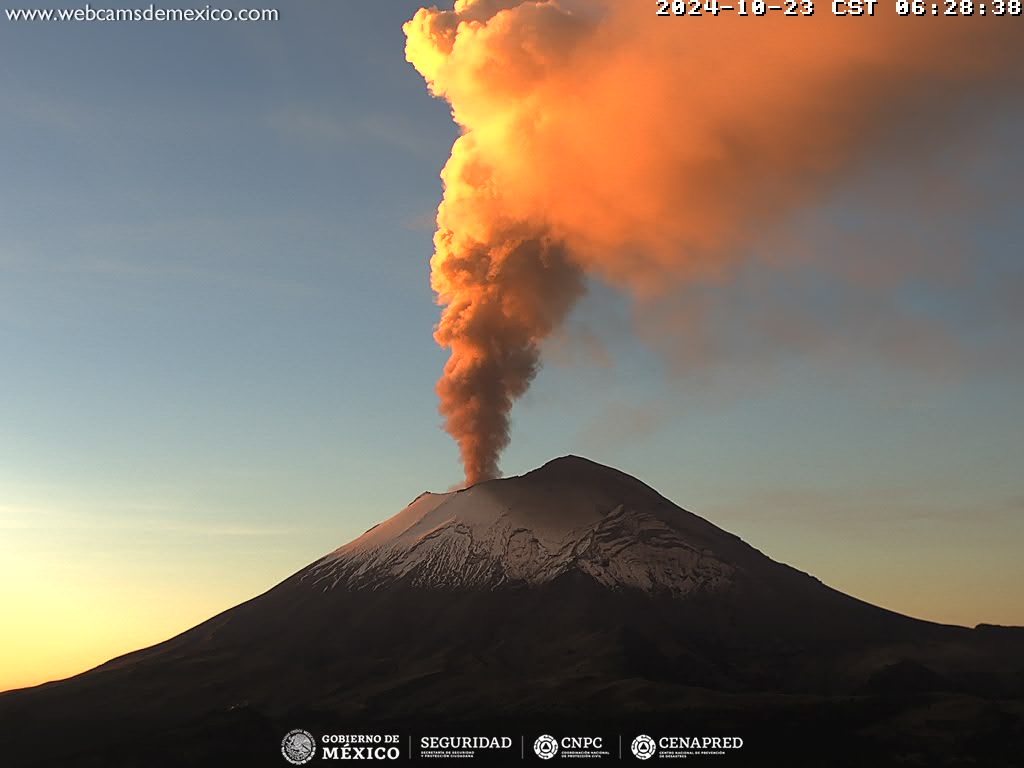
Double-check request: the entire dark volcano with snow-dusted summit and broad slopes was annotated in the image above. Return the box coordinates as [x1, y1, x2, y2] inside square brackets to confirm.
[0, 457, 1024, 766]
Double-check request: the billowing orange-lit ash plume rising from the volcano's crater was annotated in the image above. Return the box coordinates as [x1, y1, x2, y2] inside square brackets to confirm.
[404, 0, 1022, 482]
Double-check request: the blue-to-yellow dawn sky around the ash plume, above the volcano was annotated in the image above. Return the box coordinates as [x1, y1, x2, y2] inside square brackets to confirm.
[0, 0, 1024, 690]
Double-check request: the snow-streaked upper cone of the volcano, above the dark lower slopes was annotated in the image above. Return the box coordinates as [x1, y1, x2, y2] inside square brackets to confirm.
[303, 457, 753, 595]
